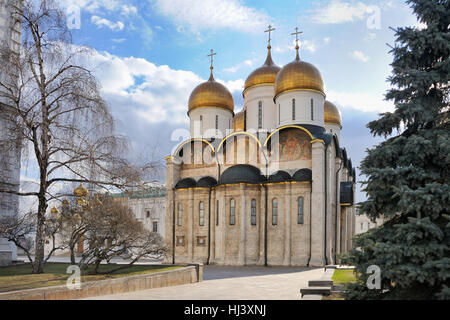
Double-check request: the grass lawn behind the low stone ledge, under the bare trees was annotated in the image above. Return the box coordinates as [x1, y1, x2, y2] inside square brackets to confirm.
[0, 263, 180, 292]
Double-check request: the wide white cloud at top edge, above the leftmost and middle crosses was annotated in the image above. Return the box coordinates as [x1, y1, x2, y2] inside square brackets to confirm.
[151, 0, 270, 32]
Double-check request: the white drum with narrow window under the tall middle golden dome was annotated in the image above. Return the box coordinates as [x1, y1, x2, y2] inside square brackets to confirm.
[244, 85, 277, 131]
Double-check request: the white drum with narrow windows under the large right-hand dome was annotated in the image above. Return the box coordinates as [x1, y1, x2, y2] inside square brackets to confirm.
[276, 91, 325, 127]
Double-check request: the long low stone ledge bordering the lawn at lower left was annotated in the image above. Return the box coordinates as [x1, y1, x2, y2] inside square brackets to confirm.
[0, 264, 203, 300]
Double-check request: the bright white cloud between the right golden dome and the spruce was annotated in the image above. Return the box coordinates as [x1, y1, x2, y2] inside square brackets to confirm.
[327, 90, 394, 113]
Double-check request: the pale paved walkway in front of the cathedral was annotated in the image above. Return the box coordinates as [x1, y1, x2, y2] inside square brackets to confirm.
[84, 266, 324, 300]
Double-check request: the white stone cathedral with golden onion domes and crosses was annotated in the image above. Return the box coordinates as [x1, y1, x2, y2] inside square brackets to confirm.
[165, 26, 356, 266]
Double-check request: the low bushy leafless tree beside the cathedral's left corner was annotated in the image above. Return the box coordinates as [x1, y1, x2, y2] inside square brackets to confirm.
[80, 196, 167, 274]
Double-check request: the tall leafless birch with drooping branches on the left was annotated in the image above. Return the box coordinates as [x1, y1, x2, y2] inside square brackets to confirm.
[0, 0, 147, 273]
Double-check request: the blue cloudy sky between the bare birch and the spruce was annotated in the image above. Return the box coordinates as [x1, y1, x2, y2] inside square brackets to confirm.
[51, 0, 424, 204]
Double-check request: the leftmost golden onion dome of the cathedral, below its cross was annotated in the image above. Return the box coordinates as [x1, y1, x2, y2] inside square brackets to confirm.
[188, 70, 234, 114]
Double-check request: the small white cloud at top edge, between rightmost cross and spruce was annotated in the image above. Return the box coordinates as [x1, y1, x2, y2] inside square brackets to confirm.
[312, 0, 370, 24]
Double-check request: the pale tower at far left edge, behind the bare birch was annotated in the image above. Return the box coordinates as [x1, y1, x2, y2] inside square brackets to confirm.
[0, 0, 23, 266]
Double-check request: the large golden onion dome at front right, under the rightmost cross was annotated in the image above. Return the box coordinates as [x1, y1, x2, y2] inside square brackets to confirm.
[274, 47, 325, 100]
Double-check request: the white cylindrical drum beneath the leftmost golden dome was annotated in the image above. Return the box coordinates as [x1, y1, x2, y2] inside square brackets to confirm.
[189, 107, 233, 138]
